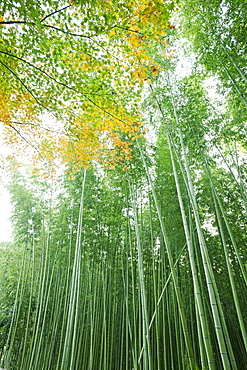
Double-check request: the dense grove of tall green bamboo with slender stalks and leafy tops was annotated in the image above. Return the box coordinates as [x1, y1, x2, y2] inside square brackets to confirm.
[0, 0, 247, 370]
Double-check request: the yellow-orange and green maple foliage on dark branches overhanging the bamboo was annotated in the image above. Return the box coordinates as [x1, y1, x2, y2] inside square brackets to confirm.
[0, 0, 178, 171]
